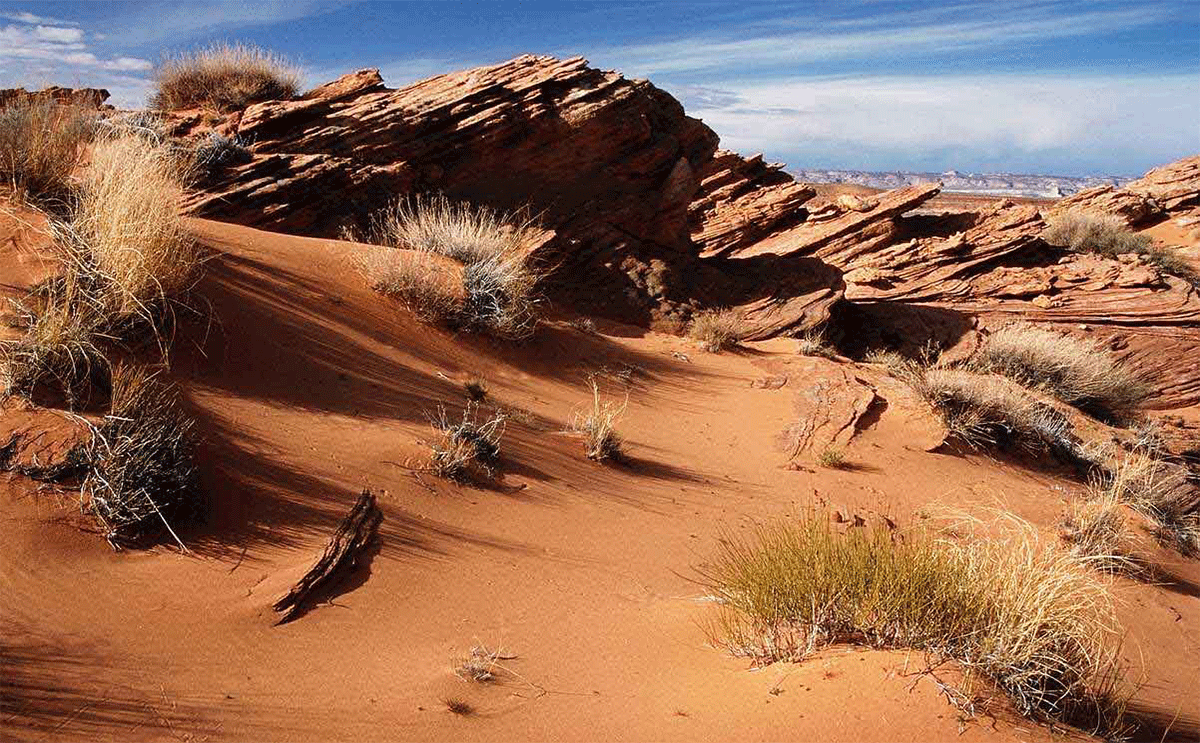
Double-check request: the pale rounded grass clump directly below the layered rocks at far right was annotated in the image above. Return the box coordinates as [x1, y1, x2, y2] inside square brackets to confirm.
[973, 323, 1152, 419]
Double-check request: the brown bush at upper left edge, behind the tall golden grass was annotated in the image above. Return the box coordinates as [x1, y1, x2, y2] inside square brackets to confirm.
[0, 98, 96, 199]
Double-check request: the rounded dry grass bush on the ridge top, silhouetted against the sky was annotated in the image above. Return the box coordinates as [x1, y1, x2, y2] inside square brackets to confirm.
[150, 44, 300, 112]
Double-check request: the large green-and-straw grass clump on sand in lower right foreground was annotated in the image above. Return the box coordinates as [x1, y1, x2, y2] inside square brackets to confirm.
[701, 519, 1121, 727]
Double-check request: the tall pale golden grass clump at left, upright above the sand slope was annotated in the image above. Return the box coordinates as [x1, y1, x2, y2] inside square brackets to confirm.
[53, 137, 200, 324]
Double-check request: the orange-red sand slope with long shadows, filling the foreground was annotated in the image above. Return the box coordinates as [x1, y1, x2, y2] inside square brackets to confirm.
[0, 221, 1200, 741]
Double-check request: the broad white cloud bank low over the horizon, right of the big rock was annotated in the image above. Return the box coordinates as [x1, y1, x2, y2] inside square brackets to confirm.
[682, 74, 1200, 172]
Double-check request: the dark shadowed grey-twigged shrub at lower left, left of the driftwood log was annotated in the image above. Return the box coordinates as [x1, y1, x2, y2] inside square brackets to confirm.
[80, 367, 197, 546]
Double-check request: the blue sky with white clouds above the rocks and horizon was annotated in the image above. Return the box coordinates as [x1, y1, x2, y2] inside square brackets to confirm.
[0, 0, 1200, 175]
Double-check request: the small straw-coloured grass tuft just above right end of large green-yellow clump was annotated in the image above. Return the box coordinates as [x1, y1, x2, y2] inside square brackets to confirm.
[1058, 489, 1140, 574]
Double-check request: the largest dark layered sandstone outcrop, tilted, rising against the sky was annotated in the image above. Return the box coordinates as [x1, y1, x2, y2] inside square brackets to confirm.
[185, 55, 842, 337]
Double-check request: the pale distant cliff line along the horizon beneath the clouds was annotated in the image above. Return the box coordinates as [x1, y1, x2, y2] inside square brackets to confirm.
[788, 168, 1130, 197]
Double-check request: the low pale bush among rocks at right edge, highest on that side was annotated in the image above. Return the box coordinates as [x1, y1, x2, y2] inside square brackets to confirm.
[1042, 211, 1200, 286]
